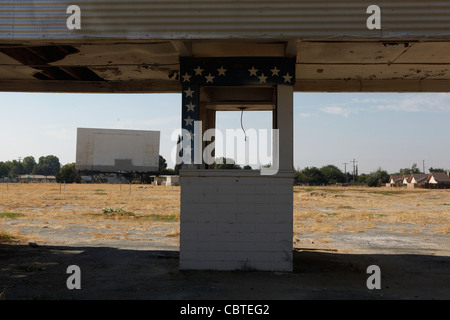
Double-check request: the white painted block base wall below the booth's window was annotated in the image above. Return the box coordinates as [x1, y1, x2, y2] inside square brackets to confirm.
[180, 170, 293, 271]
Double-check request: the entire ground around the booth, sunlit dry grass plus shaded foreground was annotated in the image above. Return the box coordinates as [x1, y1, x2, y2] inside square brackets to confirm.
[0, 185, 450, 301]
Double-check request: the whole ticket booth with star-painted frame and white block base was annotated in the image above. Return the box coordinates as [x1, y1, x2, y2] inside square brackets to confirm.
[180, 58, 295, 271]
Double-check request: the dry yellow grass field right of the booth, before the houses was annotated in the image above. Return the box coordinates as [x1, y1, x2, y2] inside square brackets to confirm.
[294, 187, 450, 234]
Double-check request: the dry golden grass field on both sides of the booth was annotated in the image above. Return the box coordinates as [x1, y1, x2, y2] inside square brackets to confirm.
[0, 183, 450, 246]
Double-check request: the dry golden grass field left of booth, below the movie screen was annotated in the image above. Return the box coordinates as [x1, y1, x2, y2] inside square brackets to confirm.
[0, 183, 180, 245]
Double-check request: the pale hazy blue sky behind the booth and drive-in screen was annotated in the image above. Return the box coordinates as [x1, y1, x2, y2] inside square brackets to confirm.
[0, 93, 450, 173]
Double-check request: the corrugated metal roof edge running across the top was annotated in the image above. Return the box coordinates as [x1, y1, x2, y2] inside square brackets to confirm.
[0, 0, 450, 40]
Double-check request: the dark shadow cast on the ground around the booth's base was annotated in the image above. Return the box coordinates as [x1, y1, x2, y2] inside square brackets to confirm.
[0, 244, 450, 300]
